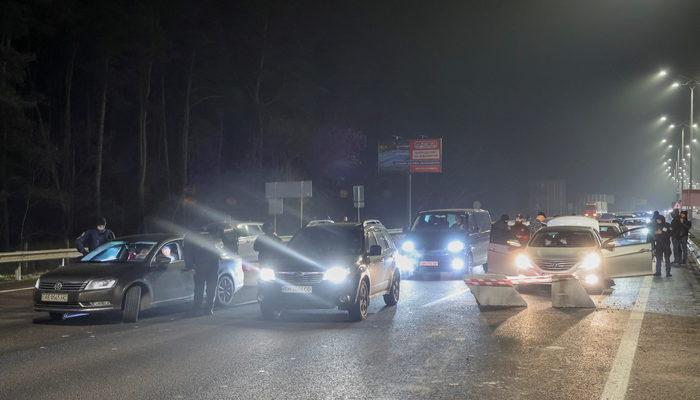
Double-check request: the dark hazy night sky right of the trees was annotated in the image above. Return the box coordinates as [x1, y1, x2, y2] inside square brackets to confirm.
[329, 1, 700, 212]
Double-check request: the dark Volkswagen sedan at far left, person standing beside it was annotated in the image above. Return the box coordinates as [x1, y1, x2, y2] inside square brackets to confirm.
[34, 234, 243, 322]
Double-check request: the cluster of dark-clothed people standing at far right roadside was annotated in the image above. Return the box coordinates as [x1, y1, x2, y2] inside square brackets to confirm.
[648, 210, 692, 277]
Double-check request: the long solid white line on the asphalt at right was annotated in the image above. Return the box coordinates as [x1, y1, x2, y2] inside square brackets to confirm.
[600, 276, 652, 400]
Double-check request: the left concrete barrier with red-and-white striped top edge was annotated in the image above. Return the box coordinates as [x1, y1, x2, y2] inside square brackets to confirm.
[464, 274, 527, 307]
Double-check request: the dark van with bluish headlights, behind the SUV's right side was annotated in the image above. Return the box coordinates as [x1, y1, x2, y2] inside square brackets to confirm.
[401, 209, 491, 276]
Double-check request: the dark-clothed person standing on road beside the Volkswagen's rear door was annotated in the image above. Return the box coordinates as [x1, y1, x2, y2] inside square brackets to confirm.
[185, 226, 223, 315]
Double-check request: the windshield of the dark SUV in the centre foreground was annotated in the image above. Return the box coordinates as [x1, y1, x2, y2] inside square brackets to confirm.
[289, 224, 363, 256]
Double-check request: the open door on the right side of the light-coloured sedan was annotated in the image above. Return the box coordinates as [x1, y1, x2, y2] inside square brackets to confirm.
[602, 228, 654, 278]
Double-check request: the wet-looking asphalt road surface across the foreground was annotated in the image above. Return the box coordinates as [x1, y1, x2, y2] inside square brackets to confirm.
[0, 269, 700, 400]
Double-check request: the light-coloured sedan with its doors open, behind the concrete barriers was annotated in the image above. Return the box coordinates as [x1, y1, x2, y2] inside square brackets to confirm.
[489, 217, 653, 293]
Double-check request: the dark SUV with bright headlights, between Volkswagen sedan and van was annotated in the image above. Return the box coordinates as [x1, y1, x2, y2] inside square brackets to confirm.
[258, 223, 401, 321]
